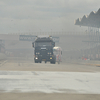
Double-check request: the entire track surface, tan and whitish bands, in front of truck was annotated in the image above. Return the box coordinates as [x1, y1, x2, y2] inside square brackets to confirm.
[0, 61, 100, 100]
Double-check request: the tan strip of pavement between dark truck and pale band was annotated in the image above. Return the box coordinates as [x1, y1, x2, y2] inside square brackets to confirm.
[0, 60, 100, 72]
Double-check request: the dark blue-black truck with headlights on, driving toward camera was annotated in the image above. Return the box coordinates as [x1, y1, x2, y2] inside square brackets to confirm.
[32, 37, 56, 64]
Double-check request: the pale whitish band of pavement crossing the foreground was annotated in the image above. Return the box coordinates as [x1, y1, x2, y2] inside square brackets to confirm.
[0, 71, 100, 94]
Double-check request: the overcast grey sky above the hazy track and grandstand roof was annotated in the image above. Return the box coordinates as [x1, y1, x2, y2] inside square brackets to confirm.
[0, 0, 100, 33]
